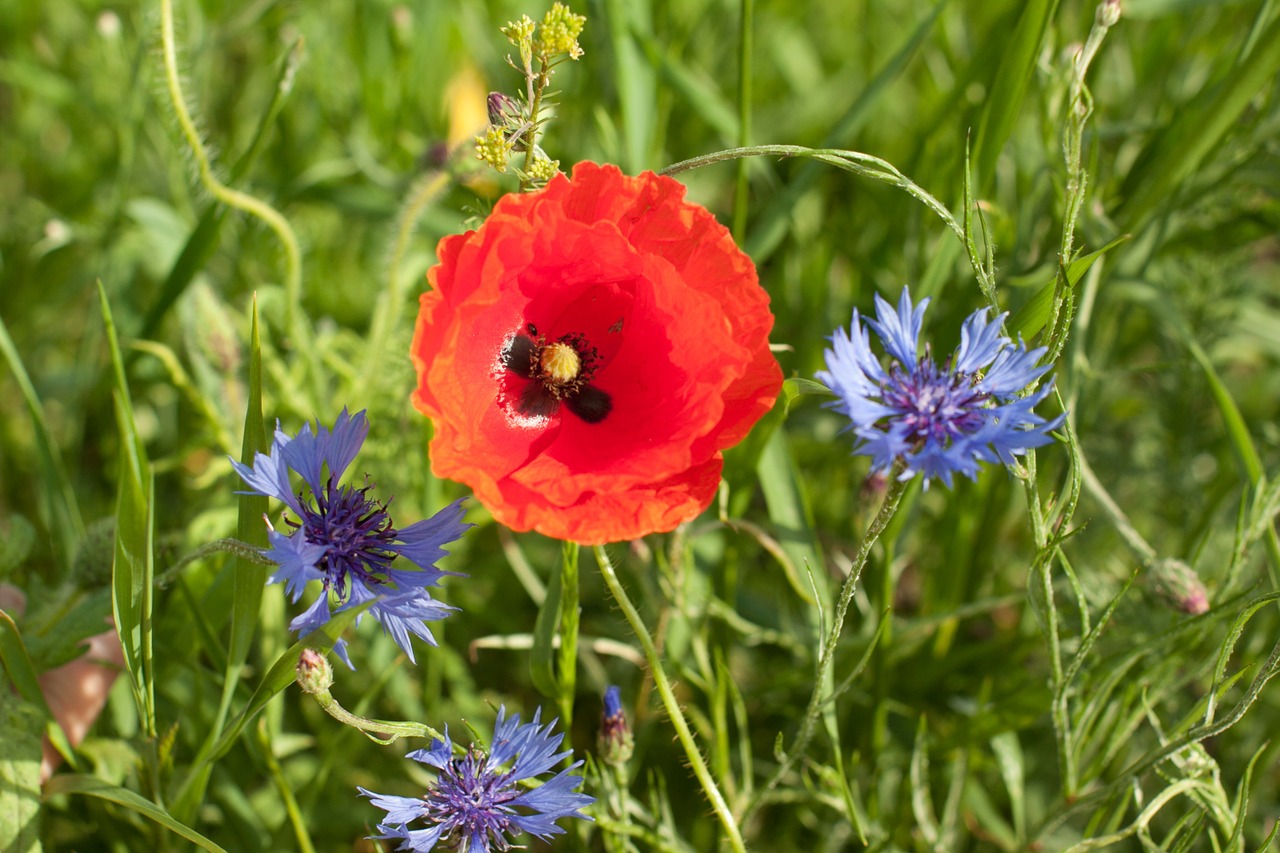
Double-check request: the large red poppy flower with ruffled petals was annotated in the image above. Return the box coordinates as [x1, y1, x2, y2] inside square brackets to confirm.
[411, 163, 782, 544]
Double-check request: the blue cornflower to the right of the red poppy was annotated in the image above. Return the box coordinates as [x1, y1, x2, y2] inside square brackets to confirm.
[817, 287, 1062, 487]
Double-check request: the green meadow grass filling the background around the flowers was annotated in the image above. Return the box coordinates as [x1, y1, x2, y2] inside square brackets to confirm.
[0, 0, 1280, 853]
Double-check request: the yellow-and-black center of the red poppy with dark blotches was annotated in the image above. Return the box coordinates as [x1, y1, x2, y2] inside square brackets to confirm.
[502, 323, 613, 424]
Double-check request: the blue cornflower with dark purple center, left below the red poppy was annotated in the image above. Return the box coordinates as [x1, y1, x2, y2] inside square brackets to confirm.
[232, 409, 471, 669]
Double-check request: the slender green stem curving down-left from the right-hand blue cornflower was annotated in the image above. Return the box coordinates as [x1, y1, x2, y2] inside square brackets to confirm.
[742, 460, 911, 824]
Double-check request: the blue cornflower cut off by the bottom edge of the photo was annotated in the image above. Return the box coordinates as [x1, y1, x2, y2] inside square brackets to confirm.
[357, 708, 595, 853]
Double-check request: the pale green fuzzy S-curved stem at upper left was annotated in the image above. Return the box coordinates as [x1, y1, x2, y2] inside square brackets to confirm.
[160, 0, 310, 350]
